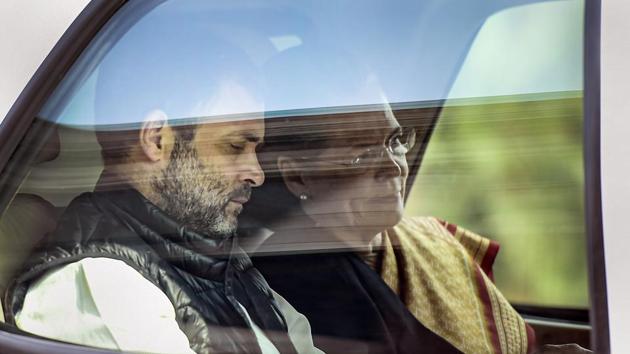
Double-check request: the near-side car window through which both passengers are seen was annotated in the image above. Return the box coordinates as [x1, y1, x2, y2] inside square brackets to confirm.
[0, 0, 590, 353]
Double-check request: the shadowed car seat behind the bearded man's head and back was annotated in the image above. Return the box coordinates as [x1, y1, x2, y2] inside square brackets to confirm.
[0, 121, 102, 321]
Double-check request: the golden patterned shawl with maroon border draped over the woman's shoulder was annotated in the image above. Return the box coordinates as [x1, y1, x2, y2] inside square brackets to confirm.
[375, 217, 534, 354]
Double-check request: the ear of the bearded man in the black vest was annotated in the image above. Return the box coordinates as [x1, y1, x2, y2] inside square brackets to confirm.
[139, 111, 172, 162]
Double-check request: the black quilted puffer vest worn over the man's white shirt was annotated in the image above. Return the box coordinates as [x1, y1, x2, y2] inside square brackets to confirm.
[4, 189, 295, 353]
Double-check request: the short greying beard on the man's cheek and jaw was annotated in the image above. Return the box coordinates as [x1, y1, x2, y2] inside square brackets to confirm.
[151, 139, 237, 238]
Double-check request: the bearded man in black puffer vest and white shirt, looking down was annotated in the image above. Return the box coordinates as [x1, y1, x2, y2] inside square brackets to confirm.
[5, 110, 320, 353]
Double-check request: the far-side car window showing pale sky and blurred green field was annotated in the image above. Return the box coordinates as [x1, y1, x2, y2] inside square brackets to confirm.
[407, 1, 588, 308]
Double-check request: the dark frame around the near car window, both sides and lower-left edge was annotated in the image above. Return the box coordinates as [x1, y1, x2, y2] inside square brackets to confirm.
[0, 0, 616, 353]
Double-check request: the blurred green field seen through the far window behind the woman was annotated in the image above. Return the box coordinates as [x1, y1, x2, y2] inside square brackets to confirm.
[406, 91, 588, 308]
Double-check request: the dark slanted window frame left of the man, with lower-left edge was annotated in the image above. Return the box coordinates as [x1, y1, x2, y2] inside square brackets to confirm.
[0, 0, 127, 354]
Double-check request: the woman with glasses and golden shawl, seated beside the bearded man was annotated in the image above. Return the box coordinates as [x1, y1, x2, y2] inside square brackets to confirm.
[247, 105, 534, 353]
